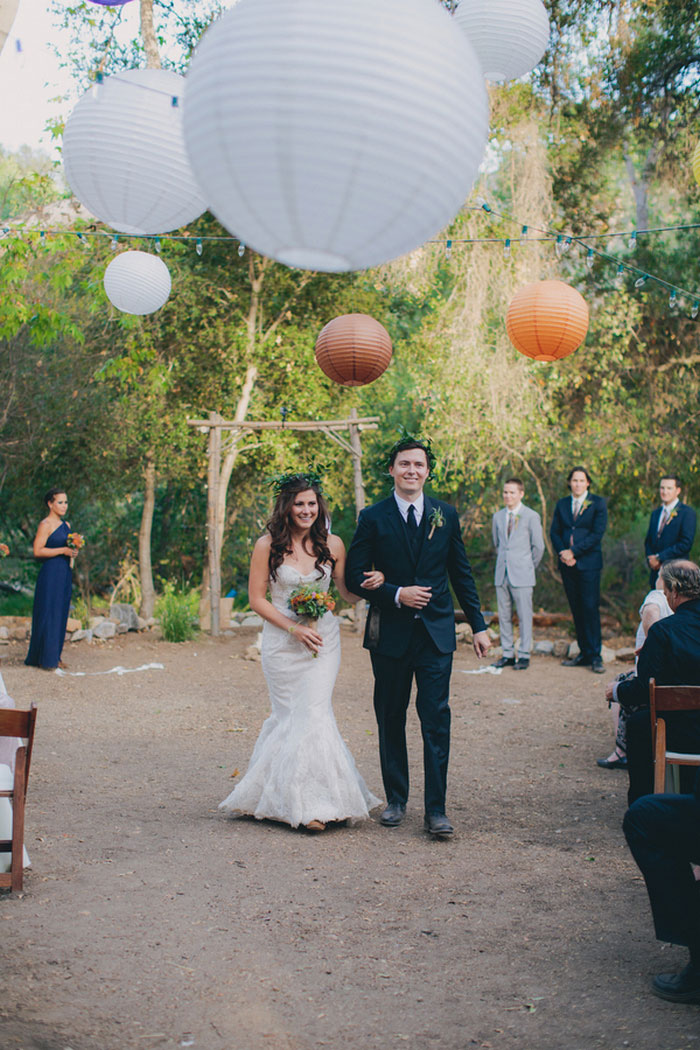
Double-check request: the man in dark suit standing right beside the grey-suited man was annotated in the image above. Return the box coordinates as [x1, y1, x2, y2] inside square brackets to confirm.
[550, 466, 608, 674]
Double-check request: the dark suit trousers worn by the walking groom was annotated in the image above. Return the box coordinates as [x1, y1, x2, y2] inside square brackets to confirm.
[370, 618, 452, 814]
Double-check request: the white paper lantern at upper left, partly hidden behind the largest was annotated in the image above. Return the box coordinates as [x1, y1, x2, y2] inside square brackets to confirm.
[63, 69, 207, 234]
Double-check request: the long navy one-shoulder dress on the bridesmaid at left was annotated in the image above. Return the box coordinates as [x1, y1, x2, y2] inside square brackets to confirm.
[24, 522, 72, 669]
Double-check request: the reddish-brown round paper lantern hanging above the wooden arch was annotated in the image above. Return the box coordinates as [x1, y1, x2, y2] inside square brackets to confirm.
[316, 314, 391, 386]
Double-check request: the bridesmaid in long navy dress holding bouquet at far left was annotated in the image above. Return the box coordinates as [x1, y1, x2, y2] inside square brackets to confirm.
[24, 488, 76, 671]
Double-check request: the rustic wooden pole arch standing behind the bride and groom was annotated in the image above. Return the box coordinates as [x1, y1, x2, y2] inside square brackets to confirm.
[187, 408, 379, 636]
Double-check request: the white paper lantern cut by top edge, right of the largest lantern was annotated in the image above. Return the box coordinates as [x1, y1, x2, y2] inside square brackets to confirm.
[454, 0, 549, 80]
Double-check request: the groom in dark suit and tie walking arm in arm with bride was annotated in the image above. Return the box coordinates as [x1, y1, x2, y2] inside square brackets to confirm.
[345, 438, 490, 838]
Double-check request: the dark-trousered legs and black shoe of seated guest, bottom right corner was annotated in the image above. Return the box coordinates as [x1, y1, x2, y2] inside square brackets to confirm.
[622, 785, 700, 1004]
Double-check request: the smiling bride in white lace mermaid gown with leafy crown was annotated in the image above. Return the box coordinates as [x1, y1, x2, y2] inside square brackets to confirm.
[219, 473, 384, 832]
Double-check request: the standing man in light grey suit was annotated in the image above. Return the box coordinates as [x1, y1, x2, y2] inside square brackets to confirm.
[491, 478, 545, 671]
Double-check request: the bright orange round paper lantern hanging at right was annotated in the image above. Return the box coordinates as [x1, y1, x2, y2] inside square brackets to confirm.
[506, 280, 588, 361]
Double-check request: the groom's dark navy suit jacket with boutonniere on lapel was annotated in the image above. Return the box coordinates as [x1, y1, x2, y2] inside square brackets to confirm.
[345, 496, 486, 658]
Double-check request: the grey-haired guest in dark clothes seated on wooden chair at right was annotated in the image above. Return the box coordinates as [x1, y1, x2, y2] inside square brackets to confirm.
[606, 561, 700, 805]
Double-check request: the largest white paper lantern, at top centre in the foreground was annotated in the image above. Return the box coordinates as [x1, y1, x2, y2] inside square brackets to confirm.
[185, 0, 488, 272]
